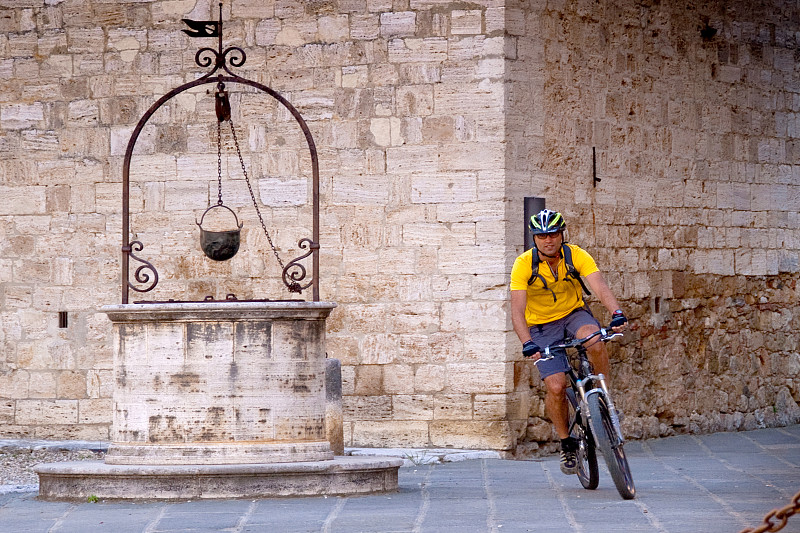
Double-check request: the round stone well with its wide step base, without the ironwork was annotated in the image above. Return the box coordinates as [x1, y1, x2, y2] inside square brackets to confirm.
[36, 301, 402, 500]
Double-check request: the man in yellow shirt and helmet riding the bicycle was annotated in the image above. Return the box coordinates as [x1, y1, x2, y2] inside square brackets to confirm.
[511, 209, 628, 474]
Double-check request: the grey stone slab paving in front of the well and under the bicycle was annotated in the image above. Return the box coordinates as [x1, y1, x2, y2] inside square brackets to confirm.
[0, 426, 800, 533]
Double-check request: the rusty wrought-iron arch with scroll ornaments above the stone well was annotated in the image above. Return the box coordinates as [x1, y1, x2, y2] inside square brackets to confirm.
[122, 5, 319, 304]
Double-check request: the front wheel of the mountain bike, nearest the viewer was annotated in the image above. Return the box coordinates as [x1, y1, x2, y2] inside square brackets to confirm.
[586, 394, 636, 500]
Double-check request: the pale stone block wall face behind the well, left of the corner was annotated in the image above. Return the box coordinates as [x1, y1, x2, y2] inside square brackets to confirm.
[0, 0, 512, 448]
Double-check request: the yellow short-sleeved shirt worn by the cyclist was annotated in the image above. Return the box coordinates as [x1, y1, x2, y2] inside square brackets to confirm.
[511, 244, 598, 326]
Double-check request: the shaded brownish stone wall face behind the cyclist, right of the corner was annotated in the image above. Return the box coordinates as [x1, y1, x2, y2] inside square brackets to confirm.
[508, 2, 800, 454]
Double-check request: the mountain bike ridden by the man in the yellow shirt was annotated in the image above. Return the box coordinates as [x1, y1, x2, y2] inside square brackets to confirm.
[534, 328, 636, 500]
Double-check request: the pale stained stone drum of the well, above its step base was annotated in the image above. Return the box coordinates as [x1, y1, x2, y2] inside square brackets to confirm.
[104, 302, 334, 464]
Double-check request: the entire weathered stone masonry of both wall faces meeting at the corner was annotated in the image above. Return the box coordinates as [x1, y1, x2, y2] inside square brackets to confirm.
[0, 0, 800, 452]
